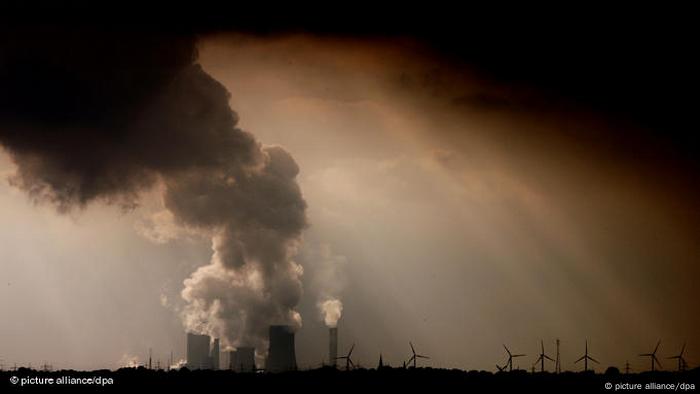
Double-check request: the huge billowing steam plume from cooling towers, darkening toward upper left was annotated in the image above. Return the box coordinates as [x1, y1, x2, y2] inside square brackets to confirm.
[0, 28, 306, 349]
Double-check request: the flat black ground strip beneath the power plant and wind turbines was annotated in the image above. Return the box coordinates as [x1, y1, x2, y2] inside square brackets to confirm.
[0, 368, 700, 393]
